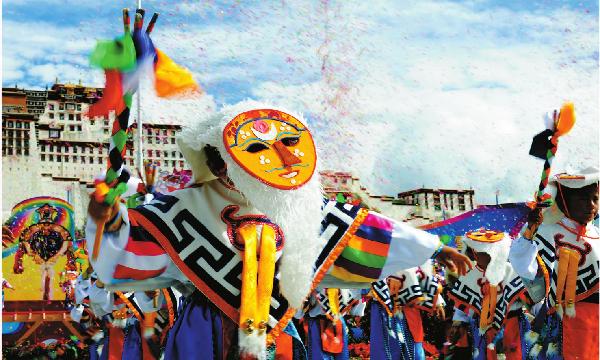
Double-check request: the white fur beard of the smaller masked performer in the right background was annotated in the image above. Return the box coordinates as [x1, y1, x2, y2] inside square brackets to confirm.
[463, 234, 511, 286]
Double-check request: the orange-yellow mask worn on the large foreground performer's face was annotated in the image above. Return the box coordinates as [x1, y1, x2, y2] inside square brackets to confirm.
[223, 109, 317, 190]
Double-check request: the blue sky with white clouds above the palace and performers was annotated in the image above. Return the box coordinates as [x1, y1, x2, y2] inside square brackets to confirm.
[2, 0, 599, 203]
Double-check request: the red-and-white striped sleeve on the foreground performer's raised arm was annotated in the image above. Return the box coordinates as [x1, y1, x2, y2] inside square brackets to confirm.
[86, 204, 178, 290]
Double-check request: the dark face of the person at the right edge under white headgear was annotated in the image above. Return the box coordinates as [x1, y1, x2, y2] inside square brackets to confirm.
[556, 183, 598, 225]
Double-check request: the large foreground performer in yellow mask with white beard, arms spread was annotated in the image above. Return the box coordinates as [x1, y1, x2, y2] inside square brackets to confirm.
[86, 101, 470, 359]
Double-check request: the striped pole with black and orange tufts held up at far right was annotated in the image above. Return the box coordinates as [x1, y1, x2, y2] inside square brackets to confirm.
[523, 102, 575, 240]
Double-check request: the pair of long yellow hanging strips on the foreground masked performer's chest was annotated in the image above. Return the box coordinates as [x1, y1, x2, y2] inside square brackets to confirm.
[238, 225, 276, 334]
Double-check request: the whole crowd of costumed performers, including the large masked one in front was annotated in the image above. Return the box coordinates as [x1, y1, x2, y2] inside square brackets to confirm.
[51, 98, 599, 359]
